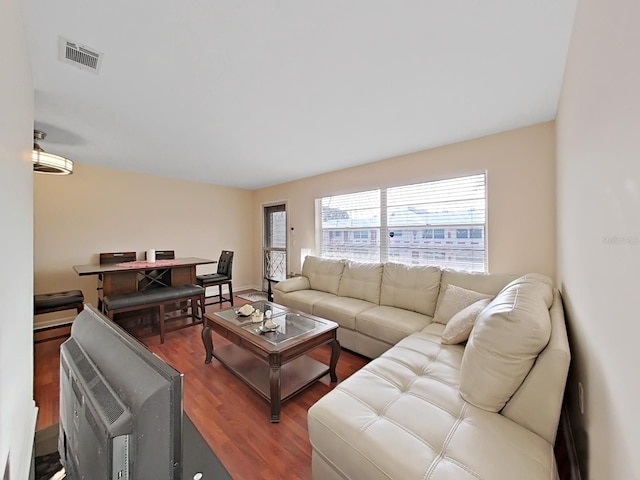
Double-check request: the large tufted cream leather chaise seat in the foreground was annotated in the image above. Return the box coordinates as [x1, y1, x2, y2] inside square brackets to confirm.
[308, 332, 555, 480]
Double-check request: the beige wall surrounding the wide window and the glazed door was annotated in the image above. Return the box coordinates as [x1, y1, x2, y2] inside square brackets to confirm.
[253, 122, 555, 282]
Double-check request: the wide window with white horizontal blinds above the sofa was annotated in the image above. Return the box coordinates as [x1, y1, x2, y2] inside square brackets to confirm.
[316, 174, 487, 272]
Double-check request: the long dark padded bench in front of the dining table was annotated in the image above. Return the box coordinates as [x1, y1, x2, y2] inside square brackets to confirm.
[103, 285, 205, 343]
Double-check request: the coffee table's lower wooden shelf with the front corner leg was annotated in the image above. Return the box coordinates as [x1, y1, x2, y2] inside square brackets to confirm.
[213, 344, 330, 423]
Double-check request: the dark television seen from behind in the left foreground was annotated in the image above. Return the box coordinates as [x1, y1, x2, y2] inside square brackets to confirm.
[58, 305, 183, 480]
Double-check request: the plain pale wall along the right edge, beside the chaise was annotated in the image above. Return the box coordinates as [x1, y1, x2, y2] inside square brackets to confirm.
[557, 0, 640, 479]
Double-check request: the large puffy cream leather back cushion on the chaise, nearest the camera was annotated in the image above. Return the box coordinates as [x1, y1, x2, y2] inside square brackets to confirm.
[460, 274, 553, 412]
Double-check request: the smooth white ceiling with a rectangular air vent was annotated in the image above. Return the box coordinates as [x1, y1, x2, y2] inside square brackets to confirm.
[22, 0, 577, 189]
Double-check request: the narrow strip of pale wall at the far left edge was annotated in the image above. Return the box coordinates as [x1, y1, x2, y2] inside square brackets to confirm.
[0, 0, 37, 479]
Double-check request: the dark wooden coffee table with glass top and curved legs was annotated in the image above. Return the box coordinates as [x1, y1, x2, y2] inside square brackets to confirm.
[202, 301, 340, 423]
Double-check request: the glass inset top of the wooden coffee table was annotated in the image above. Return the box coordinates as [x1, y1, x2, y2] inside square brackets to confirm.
[215, 301, 319, 345]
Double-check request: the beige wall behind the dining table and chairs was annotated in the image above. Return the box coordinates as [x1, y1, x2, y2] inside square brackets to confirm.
[34, 163, 253, 319]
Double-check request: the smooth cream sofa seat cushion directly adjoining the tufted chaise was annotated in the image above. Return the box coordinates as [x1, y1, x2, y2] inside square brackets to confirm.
[356, 306, 433, 345]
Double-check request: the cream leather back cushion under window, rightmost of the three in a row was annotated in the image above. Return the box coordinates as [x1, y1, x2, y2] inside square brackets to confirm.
[380, 262, 441, 317]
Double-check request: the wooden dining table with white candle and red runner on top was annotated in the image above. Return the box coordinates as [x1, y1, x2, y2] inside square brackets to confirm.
[73, 257, 217, 297]
